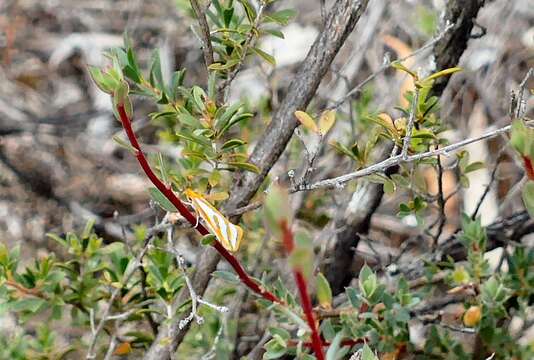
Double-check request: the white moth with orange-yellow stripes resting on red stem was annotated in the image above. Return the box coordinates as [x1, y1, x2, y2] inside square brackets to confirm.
[184, 189, 243, 252]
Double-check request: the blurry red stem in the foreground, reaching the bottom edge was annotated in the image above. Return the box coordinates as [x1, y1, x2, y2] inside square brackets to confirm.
[280, 220, 325, 360]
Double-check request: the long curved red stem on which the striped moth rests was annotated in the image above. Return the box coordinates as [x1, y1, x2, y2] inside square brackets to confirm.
[117, 104, 283, 304]
